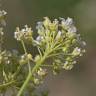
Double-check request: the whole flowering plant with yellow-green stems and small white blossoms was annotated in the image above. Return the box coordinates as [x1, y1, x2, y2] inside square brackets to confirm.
[0, 11, 86, 96]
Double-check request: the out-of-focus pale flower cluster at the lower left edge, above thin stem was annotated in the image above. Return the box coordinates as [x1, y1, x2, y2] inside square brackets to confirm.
[0, 50, 19, 83]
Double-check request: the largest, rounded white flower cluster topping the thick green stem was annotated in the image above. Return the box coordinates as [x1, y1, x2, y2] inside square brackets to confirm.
[35, 17, 86, 70]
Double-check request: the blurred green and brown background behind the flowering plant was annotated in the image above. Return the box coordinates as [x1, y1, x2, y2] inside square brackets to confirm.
[0, 0, 96, 96]
